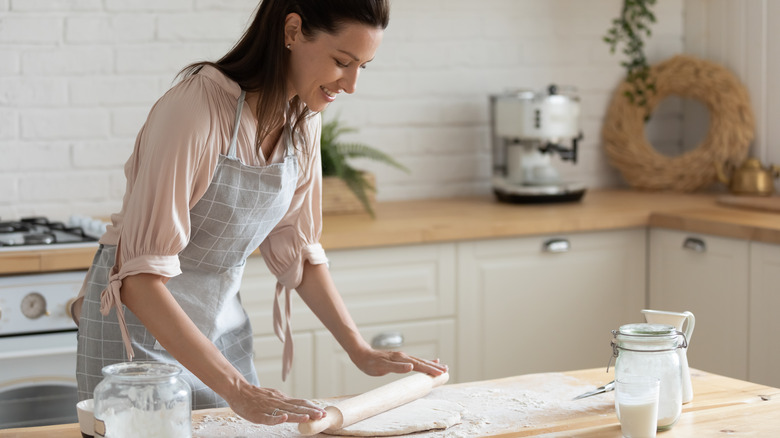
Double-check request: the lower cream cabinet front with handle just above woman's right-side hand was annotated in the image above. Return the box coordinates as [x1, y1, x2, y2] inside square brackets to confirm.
[314, 319, 456, 397]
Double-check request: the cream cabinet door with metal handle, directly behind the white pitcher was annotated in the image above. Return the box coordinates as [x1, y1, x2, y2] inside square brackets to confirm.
[649, 229, 750, 379]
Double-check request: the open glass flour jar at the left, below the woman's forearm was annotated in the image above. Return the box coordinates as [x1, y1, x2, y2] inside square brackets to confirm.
[95, 361, 192, 438]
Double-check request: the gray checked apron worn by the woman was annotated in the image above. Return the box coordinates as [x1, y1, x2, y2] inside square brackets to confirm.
[76, 91, 298, 409]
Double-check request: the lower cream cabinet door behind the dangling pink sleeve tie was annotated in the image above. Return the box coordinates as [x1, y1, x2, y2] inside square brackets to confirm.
[254, 333, 314, 398]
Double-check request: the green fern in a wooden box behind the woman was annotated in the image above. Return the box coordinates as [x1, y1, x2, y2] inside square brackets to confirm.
[320, 113, 409, 217]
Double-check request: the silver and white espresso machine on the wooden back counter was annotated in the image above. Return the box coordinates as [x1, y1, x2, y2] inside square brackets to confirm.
[490, 85, 585, 203]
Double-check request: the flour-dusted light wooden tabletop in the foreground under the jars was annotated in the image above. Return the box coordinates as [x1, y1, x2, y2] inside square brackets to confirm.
[0, 368, 780, 438]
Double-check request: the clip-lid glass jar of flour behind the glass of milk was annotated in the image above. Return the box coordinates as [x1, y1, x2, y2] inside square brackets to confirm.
[612, 323, 686, 431]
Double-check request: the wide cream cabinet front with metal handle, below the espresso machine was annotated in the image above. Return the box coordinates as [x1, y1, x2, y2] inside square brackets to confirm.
[458, 228, 647, 381]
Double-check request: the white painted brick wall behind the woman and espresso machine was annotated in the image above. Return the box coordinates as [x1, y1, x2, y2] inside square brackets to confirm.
[0, 0, 684, 219]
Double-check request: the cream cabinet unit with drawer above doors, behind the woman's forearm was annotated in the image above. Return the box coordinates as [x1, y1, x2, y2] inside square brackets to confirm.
[241, 243, 457, 398]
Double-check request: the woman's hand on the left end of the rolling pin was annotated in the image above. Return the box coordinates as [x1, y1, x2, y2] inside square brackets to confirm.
[226, 382, 325, 425]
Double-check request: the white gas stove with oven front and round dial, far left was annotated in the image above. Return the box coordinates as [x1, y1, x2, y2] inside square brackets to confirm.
[0, 216, 107, 428]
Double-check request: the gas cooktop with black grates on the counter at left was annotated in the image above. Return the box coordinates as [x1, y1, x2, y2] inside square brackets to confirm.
[0, 216, 105, 252]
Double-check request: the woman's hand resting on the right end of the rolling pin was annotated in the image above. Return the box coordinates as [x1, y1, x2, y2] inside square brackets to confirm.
[352, 348, 448, 376]
